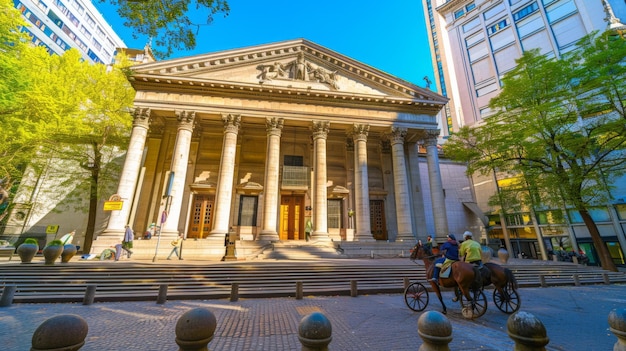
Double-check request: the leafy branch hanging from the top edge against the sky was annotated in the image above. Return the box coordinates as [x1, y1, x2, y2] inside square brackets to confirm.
[99, 0, 230, 58]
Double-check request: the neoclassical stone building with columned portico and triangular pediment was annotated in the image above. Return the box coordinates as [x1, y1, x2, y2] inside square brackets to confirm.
[94, 40, 448, 251]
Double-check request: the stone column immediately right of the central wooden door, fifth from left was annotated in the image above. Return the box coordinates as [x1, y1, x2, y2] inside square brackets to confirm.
[311, 121, 330, 241]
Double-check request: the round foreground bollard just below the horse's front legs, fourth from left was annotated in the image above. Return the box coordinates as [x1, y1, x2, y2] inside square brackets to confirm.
[417, 311, 452, 351]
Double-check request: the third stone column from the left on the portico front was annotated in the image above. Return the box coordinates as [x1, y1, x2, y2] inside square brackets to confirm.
[207, 114, 241, 241]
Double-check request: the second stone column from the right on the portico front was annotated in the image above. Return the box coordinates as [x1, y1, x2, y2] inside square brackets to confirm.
[389, 127, 415, 242]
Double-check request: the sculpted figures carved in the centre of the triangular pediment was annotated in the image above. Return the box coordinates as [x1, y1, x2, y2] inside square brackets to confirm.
[257, 52, 339, 90]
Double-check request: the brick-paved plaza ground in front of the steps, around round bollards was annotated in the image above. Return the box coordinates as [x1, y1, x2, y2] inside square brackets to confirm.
[0, 285, 626, 351]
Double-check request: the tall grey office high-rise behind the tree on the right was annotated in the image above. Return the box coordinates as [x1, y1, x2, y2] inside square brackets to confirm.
[423, 0, 626, 265]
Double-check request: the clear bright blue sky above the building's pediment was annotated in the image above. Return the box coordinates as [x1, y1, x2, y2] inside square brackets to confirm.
[94, 0, 434, 87]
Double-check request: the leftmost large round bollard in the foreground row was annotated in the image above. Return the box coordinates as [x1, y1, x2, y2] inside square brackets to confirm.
[30, 314, 89, 351]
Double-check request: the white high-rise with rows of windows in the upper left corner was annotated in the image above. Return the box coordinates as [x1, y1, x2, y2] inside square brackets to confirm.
[14, 0, 126, 64]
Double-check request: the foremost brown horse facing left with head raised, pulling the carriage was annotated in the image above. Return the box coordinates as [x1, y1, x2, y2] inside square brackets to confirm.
[411, 242, 486, 317]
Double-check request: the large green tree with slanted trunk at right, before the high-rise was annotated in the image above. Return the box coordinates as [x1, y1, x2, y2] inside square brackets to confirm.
[444, 33, 626, 270]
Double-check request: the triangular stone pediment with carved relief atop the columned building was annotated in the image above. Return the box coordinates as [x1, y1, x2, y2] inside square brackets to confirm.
[133, 39, 447, 105]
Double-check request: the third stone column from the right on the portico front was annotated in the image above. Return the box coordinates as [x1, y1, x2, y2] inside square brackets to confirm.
[352, 124, 375, 241]
